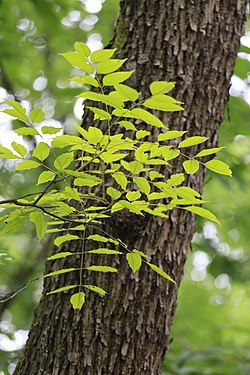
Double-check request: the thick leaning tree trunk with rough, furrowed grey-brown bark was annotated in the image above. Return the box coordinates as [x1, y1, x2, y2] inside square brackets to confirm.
[14, 0, 246, 375]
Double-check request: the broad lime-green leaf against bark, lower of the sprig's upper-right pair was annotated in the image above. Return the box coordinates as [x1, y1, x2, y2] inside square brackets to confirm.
[143, 94, 184, 112]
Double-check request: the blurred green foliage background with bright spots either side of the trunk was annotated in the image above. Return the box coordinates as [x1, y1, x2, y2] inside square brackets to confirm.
[0, 0, 250, 375]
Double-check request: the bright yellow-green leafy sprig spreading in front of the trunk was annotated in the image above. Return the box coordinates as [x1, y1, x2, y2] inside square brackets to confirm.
[0, 42, 231, 309]
